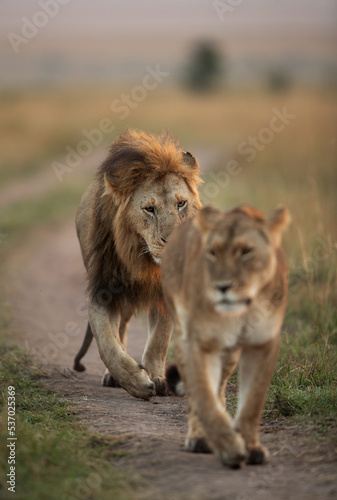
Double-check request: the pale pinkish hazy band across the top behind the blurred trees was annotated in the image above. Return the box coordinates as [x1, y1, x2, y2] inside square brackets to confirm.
[0, 0, 337, 84]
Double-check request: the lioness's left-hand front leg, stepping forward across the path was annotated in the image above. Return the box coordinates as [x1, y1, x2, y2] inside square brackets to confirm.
[184, 344, 245, 468]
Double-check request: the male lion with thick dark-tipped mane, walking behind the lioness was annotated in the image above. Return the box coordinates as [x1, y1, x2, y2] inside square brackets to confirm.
[74, 130, 201, 399]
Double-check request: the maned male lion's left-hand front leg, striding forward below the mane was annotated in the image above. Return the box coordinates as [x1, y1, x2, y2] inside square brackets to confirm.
[89, 303, 154, 399]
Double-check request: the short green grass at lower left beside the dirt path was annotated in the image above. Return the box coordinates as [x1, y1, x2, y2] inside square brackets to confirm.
[0, 344, 144, 500]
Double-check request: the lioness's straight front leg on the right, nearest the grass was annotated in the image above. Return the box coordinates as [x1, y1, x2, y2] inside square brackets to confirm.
[236, 336, 280, 464]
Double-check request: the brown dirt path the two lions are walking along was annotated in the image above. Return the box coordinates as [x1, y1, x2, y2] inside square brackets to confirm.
[4, 221, 337, 500]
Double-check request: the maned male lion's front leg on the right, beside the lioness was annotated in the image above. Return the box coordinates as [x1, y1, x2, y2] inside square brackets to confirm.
[142, 309, 173, 395]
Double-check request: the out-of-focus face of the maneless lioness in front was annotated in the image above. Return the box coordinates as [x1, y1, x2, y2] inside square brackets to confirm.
[205, 215, 276, 313]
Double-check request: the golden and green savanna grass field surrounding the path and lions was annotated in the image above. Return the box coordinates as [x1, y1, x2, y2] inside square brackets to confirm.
[0, 88, 337, 500]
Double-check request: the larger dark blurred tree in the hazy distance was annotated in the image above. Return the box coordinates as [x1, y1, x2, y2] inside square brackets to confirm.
[185, 42, 224, 92]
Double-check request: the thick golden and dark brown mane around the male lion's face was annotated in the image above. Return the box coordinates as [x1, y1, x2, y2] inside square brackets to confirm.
[86, 131, 200, 312]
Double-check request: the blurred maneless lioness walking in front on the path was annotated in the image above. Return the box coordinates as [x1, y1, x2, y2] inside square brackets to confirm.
[161, 206, 290, 468]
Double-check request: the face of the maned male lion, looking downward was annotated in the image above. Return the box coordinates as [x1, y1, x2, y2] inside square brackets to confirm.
[129, 174, 198, 265]
